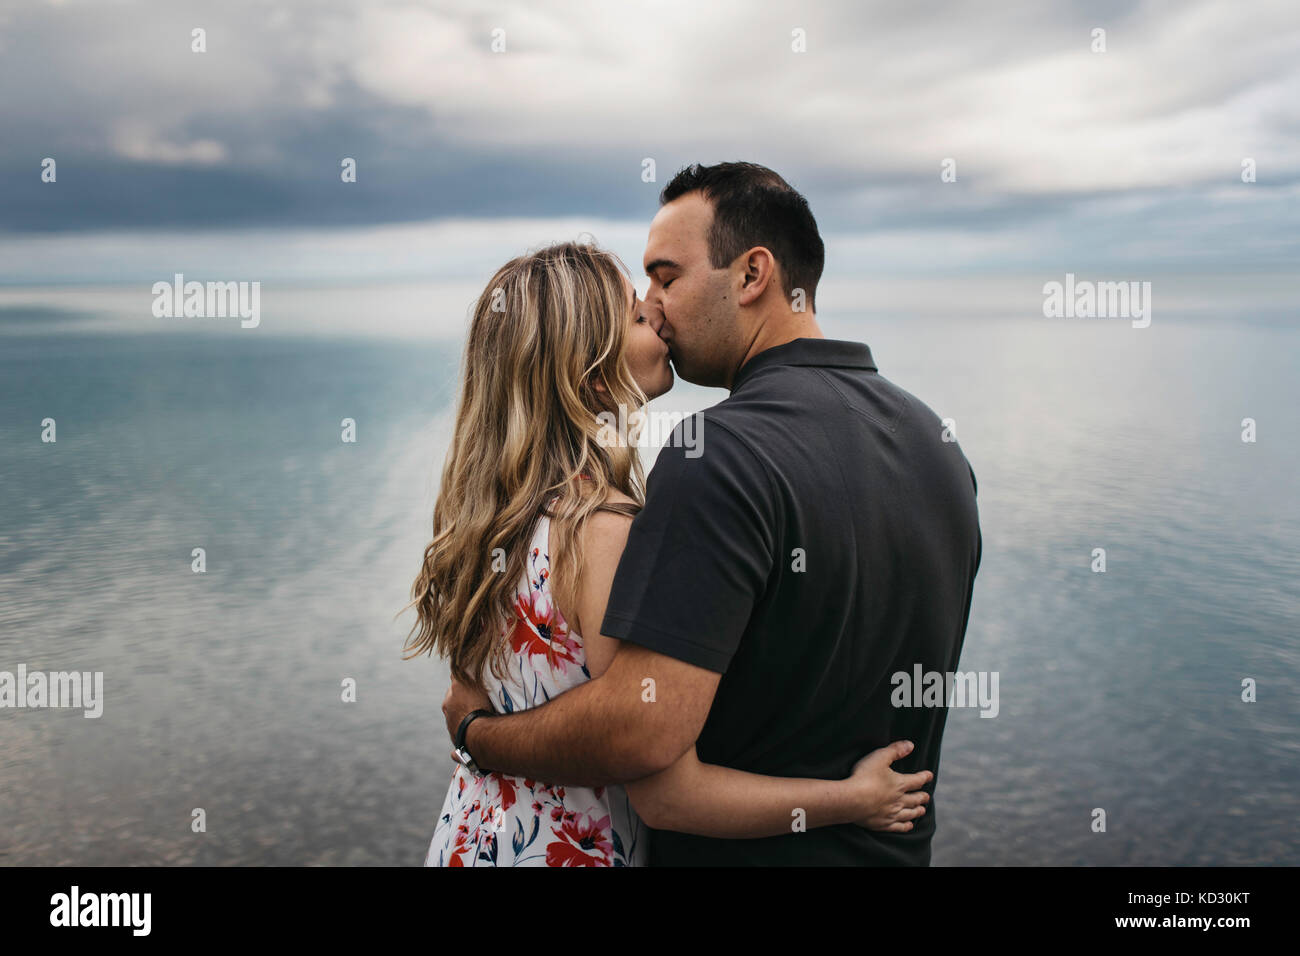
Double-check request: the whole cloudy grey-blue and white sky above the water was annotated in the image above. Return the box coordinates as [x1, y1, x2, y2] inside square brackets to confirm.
[0, 0, 1300, 284]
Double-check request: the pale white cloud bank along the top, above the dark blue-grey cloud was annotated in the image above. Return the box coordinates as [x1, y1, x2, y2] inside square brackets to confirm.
[10, 0, 1300, 194]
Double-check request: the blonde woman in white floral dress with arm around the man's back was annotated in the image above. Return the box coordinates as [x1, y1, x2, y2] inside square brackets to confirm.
[407, 243, 931, 866]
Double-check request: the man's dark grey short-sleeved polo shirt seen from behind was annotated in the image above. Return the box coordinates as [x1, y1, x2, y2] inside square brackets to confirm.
[602, 338, 982, 865]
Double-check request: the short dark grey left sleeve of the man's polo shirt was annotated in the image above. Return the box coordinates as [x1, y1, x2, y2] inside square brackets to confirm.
[601, 418, 776, 674]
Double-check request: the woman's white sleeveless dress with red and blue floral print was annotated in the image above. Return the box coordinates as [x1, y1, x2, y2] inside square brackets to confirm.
[424, 515, 650, 866]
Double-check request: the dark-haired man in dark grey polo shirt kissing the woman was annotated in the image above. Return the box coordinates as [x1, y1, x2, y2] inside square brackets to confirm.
[443, 163, 982, 865]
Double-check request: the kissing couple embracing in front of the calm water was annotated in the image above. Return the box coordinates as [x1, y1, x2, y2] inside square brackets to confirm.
[406, 163, 982, 866]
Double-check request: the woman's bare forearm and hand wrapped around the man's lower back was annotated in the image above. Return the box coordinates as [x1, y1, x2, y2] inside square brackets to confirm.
[625, 741, 933, 839]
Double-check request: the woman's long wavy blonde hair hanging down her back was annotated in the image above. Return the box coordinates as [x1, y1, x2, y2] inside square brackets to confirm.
[403, 242, 646, 689]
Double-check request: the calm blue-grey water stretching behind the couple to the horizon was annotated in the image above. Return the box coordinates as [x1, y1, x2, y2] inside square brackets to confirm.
[0, 297, 1300, 865]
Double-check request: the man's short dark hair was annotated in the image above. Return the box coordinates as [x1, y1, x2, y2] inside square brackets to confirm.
[659, 163, 826, 311]
